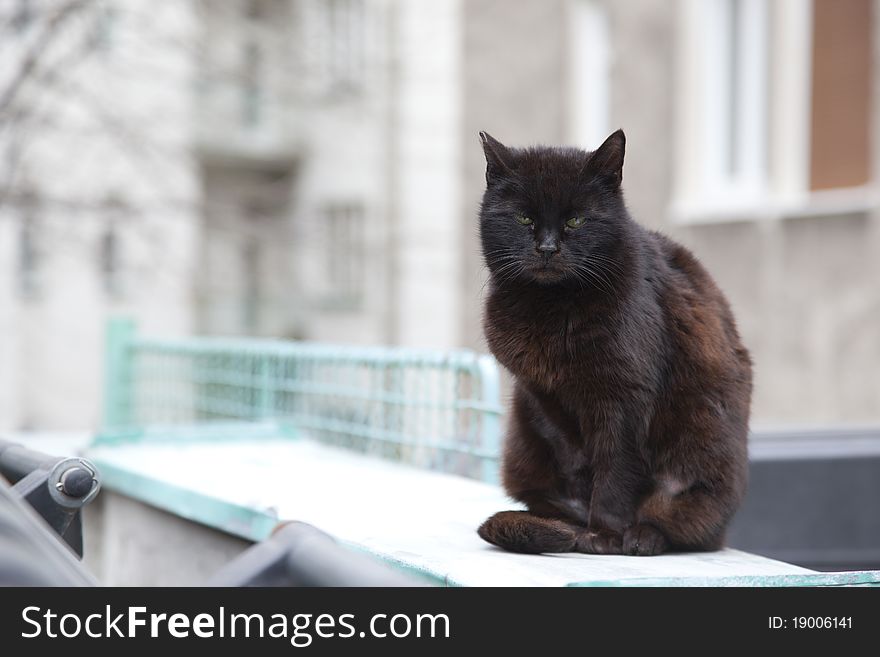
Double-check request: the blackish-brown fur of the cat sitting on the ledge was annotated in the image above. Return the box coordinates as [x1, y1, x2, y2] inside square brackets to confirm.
[479, 131, 752, 555]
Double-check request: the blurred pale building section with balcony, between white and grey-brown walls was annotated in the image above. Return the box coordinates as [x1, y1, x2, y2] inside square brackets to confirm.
[199, 0, 462, 347]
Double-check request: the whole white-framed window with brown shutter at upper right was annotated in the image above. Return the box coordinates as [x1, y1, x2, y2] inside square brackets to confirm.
[673, 0, 873, 221]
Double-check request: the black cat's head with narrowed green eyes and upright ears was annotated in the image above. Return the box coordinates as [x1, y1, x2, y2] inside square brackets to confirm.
[480, 130, 631, 289]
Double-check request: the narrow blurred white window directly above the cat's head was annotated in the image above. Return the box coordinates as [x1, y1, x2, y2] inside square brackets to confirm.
[568, 0, 611, 150]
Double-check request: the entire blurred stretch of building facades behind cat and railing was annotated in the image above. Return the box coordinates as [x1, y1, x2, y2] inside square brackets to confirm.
[0, 0, 880, 429]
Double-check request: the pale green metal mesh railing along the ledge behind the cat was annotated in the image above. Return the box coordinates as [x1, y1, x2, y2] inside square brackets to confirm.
[96, 319, 501, 482]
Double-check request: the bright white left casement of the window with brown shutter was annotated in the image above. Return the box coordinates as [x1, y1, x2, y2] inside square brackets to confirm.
[676, 0, 771, 220]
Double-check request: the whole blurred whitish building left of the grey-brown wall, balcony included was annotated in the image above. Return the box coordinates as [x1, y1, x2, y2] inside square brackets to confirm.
[0, 0, 470, 429]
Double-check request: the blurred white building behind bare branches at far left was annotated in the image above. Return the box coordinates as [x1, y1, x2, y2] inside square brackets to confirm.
[0, 0, 200, 430]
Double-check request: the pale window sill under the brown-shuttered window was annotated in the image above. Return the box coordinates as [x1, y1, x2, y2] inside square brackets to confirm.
[669, 185, 880, 226]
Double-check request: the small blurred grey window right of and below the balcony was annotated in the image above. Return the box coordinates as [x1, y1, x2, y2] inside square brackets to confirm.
[321, 203, 366, 310]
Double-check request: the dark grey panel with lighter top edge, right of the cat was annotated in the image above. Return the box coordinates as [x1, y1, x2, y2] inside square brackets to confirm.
[728, 428, 880, 570]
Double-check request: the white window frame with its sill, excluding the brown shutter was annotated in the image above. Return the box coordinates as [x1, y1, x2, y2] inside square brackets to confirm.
[670, 0, 876, 224]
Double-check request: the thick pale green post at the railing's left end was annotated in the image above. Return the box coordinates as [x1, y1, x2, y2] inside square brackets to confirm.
[104, 317, 136, 430]
